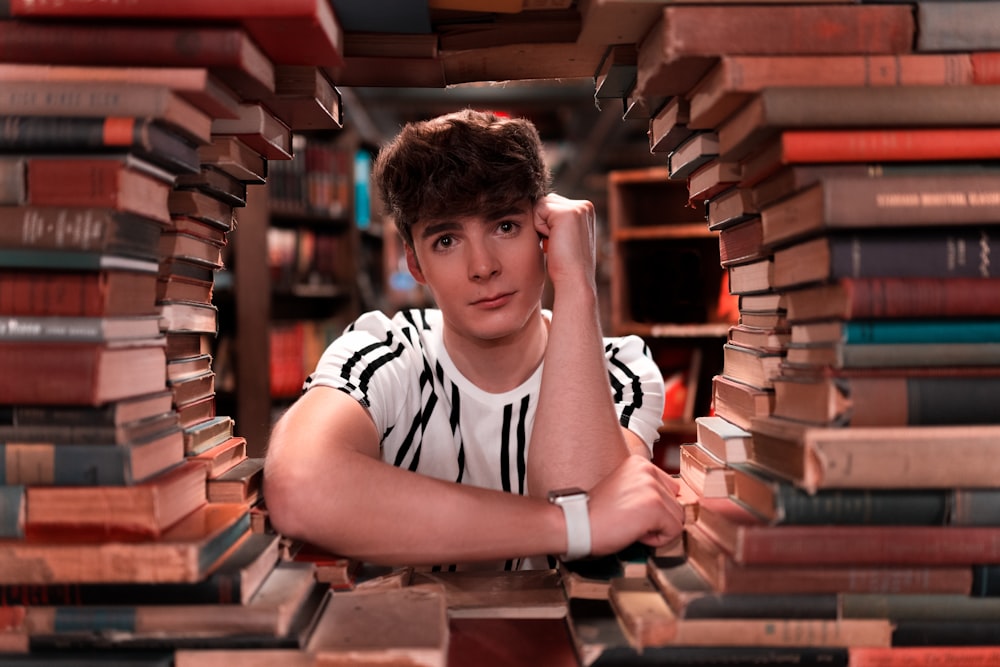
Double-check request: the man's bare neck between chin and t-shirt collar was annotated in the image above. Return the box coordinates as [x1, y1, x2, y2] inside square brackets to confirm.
[444, 309, 549, 394]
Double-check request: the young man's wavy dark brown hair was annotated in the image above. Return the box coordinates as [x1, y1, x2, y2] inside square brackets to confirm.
[373, 109, 551, 246]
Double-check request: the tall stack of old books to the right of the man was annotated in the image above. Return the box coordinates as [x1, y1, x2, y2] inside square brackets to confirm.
[571, 2, 1000, 665]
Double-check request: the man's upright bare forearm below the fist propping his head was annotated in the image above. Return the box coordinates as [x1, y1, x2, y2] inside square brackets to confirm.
[528, 285, 628, 495]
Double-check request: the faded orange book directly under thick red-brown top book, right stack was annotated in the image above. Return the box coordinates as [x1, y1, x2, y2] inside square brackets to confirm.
[688, 53, 986, 129]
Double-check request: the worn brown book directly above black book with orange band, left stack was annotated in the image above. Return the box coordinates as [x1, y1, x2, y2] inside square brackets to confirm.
[0, 81, 212, 144]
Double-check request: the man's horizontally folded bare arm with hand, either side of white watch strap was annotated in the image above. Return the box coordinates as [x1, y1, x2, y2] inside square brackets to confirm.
[265, 387, 676, 565]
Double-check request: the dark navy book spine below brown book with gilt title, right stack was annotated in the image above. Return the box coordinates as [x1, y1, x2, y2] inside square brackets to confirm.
[829, 229, 993, 278]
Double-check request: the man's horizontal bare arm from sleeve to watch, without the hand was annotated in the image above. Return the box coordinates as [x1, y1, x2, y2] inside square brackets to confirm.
[265, 399, 566, 565]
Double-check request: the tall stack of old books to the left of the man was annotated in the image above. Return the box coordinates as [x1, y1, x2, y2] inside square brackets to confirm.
[0, 2, 341, 664]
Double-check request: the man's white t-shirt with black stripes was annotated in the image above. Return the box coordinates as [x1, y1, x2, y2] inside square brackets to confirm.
[305, 309, 663, 567]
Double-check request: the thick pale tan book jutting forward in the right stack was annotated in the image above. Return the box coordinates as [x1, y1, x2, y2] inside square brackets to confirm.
[749, 416, 1000, 492]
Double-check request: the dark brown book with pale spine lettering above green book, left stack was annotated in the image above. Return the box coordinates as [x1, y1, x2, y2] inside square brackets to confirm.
[0, 205, 162, 259]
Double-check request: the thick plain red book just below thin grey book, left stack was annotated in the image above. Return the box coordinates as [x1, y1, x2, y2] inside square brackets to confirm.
[0, 339, 166, 405]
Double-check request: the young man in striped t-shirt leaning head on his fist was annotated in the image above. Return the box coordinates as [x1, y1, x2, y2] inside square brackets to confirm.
[265, 110, 683, 568]
